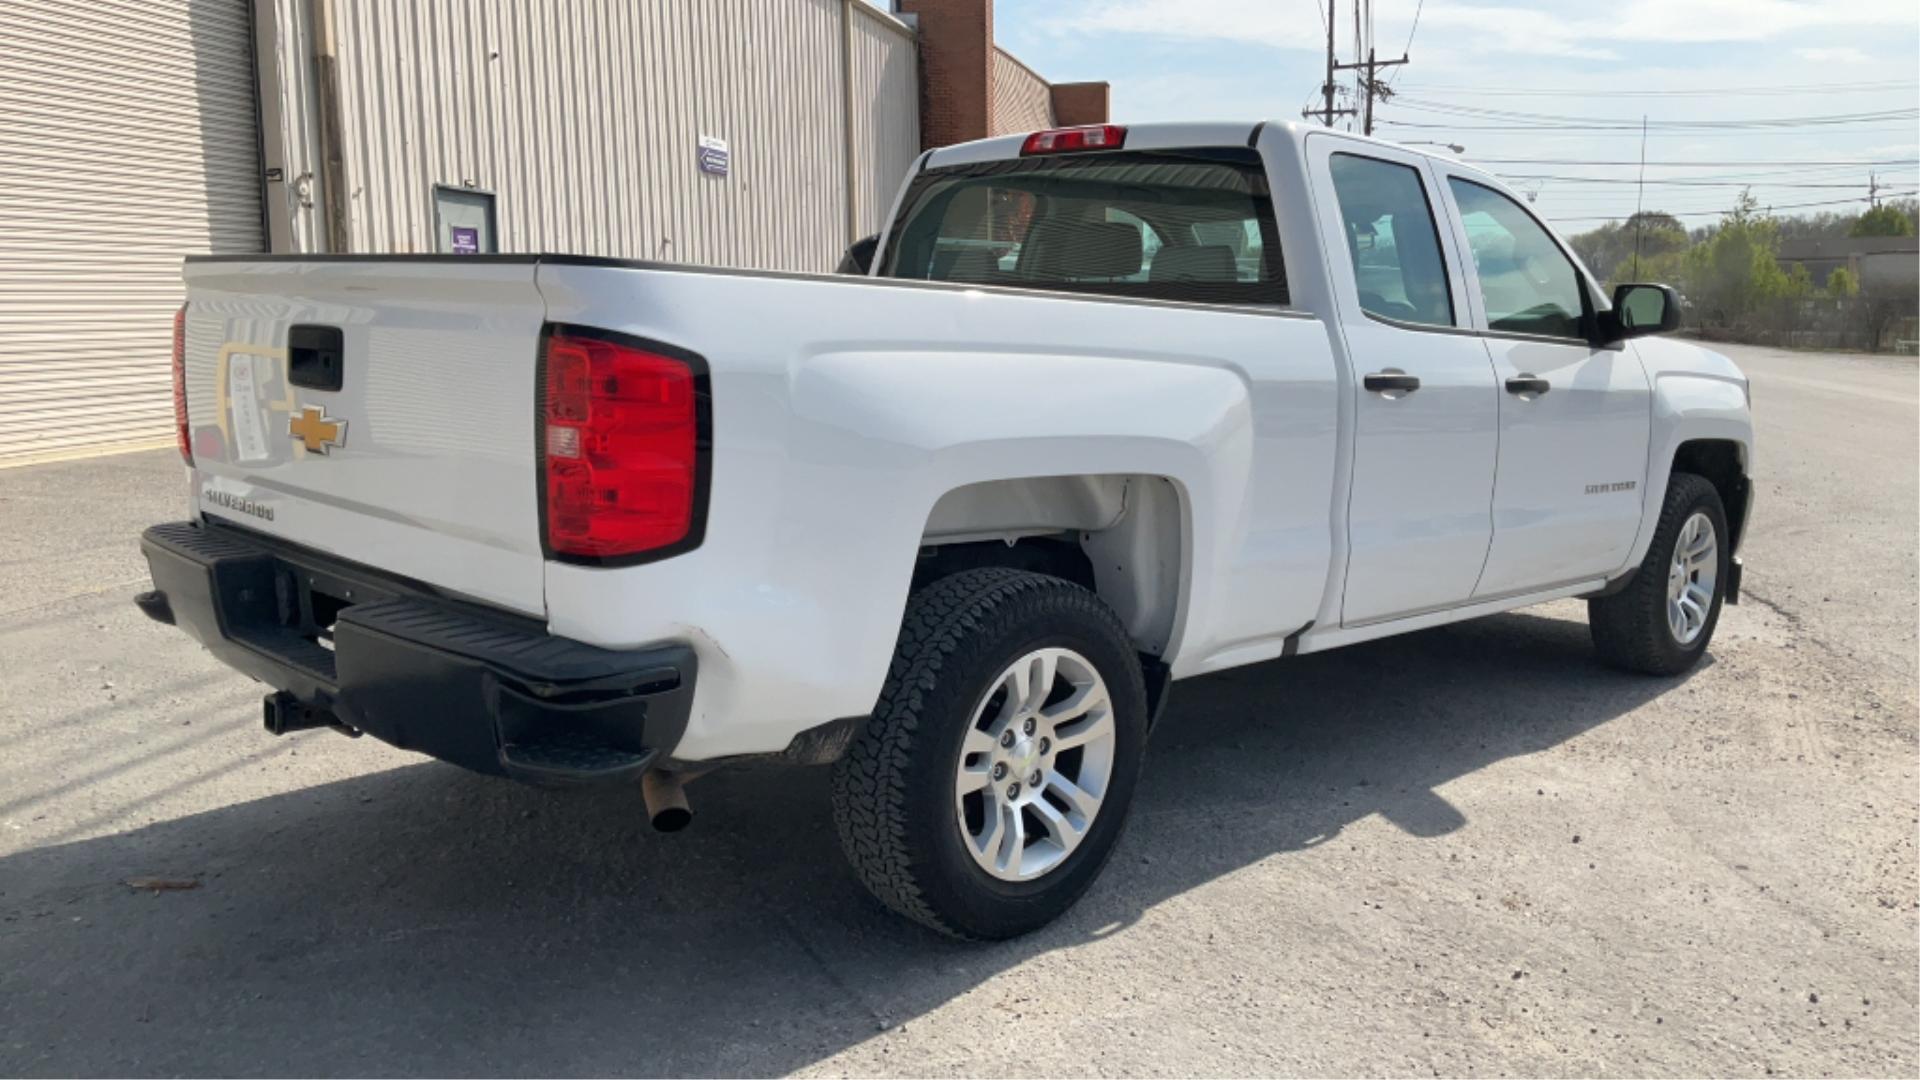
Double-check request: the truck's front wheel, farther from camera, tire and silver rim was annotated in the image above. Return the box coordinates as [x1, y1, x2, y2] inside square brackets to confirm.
[1586, 473, 1732, 675]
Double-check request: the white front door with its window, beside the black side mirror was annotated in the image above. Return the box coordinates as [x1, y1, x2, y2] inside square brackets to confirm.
[1448, 175, 1653, 598]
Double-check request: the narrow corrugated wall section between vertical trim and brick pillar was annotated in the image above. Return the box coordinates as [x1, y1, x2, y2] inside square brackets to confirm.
[849, 2, 920, 236]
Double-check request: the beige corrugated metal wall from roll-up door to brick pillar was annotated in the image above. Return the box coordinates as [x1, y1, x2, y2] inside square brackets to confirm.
[295, 0, 918, 271]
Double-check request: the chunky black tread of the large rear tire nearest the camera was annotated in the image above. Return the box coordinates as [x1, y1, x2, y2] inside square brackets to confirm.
[833, 567, 1144, 940]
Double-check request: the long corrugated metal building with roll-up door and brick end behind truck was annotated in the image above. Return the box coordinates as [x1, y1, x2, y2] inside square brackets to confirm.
[0, 0, 1108, 465]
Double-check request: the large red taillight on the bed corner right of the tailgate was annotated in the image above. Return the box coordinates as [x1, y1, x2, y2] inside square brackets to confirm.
[540, 329, 707, 563]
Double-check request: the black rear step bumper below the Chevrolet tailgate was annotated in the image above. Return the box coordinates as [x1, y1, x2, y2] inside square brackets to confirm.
[136, 523, 697, 782]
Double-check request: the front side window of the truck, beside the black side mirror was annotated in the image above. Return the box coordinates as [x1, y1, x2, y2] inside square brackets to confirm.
[1448, 177, 1586, 338]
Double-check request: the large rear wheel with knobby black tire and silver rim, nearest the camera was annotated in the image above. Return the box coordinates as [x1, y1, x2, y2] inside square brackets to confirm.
[833, 567, 1146, 940]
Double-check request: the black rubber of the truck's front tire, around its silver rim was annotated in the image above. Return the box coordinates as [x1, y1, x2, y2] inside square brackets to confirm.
[1586, 473, 1728, 675]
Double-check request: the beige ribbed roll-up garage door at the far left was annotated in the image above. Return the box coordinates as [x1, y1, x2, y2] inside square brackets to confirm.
[0, 0, 263, 467]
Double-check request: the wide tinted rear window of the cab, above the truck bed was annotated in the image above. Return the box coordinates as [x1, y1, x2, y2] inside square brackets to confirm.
[881, 150, 1286, 304]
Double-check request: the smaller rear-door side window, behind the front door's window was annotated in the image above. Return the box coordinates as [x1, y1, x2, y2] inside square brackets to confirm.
[1329, 154, 1453, 327]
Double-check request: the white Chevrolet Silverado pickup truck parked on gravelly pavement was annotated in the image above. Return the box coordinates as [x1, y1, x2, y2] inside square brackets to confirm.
[138, 123, 1753, 938]
